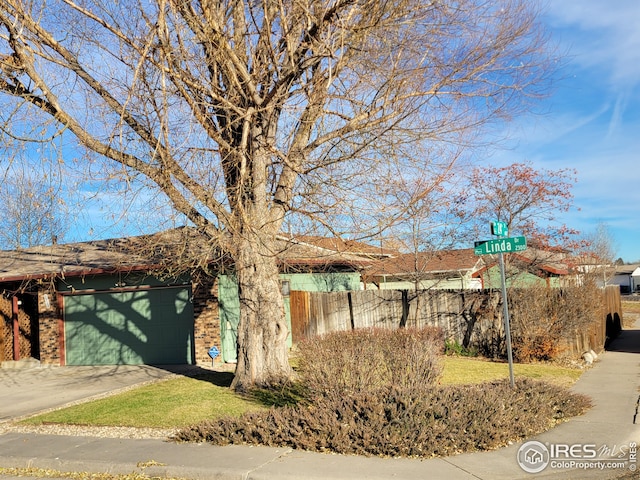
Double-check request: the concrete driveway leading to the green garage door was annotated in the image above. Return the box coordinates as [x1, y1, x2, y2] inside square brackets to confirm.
[0, 365, 175, 423]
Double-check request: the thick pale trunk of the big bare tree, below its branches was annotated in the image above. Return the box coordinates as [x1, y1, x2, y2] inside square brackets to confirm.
[232, 234, 292, 390]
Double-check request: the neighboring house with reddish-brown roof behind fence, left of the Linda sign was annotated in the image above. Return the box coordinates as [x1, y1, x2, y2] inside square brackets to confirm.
[362, 248, 484, 290]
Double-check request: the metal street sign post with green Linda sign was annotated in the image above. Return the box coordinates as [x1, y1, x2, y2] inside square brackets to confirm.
[473, 222, 527, 388]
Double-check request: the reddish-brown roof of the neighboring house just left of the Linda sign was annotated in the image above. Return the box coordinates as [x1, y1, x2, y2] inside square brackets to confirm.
[367, 248, 482, 276]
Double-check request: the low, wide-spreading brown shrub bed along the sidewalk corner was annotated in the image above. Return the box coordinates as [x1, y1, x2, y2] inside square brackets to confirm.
[174, 379, 589, 457]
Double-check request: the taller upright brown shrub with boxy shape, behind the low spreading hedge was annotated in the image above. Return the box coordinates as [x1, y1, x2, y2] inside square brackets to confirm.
[299, 327, 444, 398]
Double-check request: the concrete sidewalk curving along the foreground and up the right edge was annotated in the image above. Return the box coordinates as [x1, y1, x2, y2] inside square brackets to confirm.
[0, 330, 640, 480]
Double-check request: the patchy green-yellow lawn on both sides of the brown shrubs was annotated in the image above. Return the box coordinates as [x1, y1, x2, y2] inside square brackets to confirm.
[23, 357, 581, 428]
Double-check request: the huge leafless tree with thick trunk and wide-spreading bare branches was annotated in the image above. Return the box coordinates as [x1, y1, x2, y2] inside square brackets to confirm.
[0, 0, 551, 388]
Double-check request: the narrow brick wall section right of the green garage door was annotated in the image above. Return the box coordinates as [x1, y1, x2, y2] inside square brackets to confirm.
[192, 275, 221, 363]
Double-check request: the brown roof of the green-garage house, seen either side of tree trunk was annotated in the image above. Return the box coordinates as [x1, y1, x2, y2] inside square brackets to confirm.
[0, 228, 374, 282]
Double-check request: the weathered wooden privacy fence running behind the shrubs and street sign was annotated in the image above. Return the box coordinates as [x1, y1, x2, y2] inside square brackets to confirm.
[290, 288, 622, 357]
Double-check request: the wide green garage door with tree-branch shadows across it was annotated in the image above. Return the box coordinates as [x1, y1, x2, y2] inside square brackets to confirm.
[64, 287, 193, 365]
